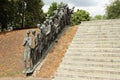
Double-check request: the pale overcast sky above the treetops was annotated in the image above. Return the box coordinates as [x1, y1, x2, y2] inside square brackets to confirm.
[43, 0, 109, 16]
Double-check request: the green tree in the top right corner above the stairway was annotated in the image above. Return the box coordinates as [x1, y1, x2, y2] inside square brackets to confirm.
[106, 0, 120, 19]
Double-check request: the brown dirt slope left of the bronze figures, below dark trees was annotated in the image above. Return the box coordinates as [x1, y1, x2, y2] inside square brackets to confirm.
[0, 29, 38, 77]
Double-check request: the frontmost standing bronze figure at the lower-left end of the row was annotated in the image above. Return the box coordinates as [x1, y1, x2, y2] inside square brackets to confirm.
[23, 30, 32, 73]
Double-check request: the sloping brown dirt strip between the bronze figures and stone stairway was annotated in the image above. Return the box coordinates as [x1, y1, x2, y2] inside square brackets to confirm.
[37, 26, 78, 78]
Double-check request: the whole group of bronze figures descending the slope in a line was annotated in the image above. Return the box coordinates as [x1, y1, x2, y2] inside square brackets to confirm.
[23, 4, 74, 73]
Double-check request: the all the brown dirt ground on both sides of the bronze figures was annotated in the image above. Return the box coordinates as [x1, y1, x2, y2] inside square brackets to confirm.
[0, 26, 78, 78]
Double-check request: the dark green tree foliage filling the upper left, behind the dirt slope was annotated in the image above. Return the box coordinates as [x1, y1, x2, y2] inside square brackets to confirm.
[0, 0, 45, 31]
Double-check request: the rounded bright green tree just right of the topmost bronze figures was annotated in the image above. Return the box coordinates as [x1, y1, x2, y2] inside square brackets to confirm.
[72, 9, 90, 25]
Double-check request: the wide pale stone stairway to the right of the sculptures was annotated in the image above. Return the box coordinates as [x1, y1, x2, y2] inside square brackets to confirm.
[53, 20, 120, 80]
